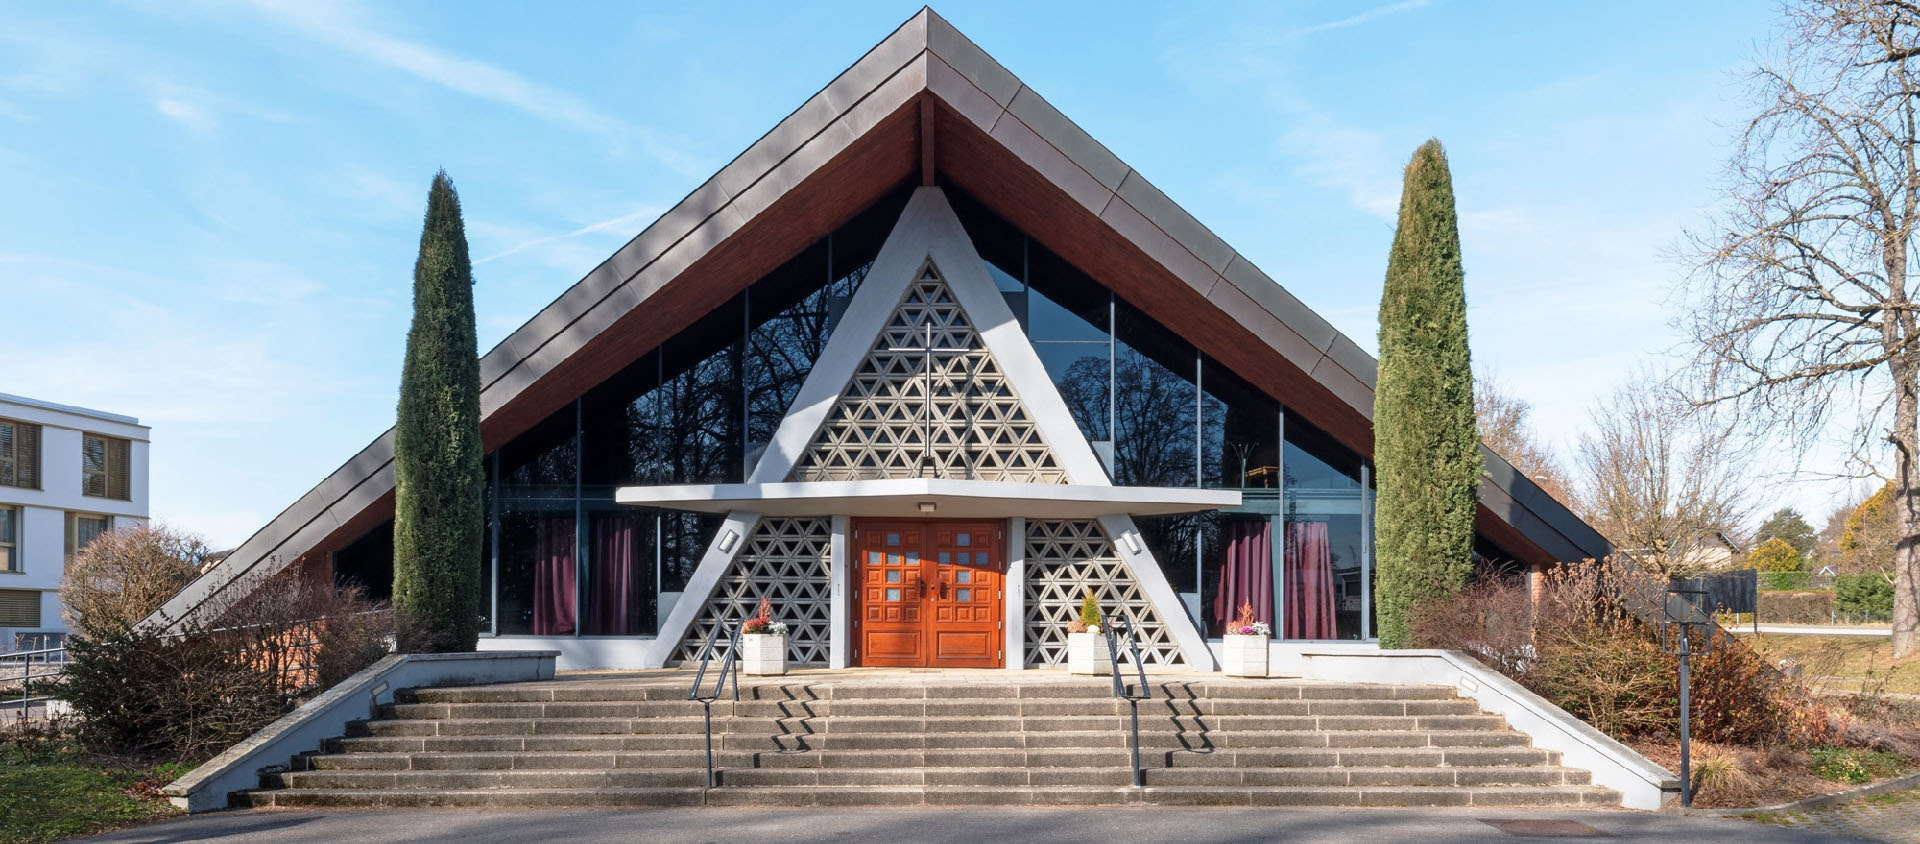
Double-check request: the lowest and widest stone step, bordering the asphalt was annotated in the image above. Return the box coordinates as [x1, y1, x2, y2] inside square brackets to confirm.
[236, 785, 1619, 808]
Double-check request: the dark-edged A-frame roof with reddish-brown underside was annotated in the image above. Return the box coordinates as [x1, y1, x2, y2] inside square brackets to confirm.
[149, 8, 1611, 618]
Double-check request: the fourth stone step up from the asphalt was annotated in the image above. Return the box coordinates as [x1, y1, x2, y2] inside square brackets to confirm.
[324, 729, 1528, 754]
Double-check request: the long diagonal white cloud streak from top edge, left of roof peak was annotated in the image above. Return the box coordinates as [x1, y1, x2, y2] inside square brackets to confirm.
[253, 0, 701, 175]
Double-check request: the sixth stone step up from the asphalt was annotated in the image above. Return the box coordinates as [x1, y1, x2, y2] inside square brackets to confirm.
[378, 698, 1478, 721]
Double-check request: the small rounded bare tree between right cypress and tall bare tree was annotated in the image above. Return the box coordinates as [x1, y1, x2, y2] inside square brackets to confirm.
[1574, 376, 1751, 574]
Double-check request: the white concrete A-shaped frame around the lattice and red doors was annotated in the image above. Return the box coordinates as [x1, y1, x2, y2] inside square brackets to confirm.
[653, 188, 1213, 669]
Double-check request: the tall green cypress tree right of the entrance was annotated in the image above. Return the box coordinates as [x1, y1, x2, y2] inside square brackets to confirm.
[1373, 140, 1484, 648]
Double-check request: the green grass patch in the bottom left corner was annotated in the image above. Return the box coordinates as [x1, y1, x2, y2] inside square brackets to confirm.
[0, 746, 192, 844]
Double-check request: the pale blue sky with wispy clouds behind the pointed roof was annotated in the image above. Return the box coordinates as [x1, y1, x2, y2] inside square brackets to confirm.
[0, 0, 1837, 545]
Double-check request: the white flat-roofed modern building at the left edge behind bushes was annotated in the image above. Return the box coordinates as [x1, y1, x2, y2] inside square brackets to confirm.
[0, 393, 150, 652]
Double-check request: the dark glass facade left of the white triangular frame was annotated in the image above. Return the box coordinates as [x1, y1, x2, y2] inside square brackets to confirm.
[476, 194, 904, 637]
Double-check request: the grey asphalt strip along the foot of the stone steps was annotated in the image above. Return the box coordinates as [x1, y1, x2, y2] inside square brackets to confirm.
[71, 808, 1860, 844]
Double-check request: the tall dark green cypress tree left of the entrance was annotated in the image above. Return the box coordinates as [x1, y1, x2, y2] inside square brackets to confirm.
[394, 171, 486, 652]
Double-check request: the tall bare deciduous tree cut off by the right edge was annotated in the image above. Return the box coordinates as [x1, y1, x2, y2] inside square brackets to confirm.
[1688, 0, 1920, 654]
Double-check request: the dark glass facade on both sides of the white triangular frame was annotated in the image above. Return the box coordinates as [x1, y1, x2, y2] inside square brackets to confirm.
[318, 192, 1503, 641]
